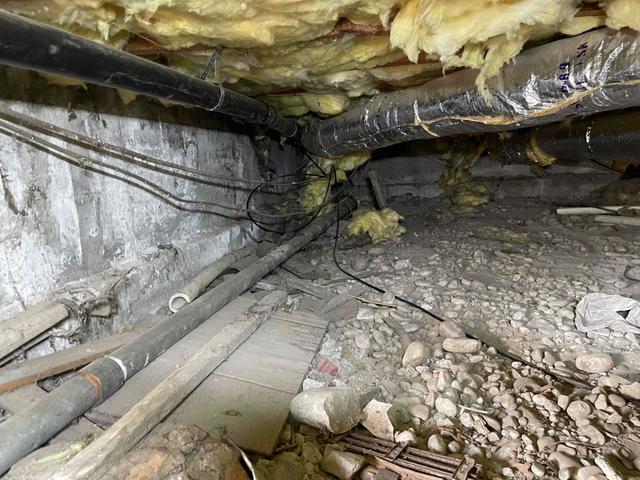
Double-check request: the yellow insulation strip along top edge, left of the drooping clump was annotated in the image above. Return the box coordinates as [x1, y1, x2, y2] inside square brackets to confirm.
[3, 0, 397, 50]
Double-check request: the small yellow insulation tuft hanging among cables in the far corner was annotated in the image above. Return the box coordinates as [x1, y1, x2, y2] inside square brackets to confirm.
[300, 152, 371, 209]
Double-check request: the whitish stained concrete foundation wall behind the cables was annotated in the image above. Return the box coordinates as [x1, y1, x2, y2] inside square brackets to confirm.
[0, 69, 296, 344]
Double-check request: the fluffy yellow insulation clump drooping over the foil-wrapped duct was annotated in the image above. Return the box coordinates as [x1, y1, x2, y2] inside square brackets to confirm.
[390, 0, 579, 90]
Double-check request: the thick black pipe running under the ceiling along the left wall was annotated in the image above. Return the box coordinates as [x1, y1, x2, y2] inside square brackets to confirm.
[0, 11, 297, 137]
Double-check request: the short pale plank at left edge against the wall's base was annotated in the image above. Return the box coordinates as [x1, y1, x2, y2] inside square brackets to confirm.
[0, 302, 69, 359]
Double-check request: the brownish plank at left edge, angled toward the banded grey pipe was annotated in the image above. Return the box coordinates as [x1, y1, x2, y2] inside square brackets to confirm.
[0, 332, 139, 393]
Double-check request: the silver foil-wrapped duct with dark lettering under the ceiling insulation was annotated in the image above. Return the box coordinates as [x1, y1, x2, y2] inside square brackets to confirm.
[302, 29, 640, 156]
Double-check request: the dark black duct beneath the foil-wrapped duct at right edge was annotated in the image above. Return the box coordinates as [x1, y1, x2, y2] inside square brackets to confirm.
[488, 109, 640, 165]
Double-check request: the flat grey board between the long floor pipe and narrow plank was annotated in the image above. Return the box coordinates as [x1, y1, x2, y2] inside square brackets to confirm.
[85, 295, 255, 428]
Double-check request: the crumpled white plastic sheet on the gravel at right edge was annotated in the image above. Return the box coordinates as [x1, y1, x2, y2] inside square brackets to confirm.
[576, 293, 640, 333]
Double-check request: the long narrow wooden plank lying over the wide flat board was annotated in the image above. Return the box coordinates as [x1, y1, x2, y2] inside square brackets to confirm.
[52, 292, 284, 480]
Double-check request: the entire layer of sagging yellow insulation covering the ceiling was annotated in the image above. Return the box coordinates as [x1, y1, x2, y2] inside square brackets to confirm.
[3, 0, 640, 116]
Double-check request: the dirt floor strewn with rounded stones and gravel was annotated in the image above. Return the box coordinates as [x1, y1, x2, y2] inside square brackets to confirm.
[262, 201, 640, 480]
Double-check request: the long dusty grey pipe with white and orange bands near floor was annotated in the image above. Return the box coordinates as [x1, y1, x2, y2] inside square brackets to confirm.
[0, 215, 336, 475]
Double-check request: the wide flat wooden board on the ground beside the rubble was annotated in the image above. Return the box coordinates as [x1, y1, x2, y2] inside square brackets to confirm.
[167, 312, 327, 455]
